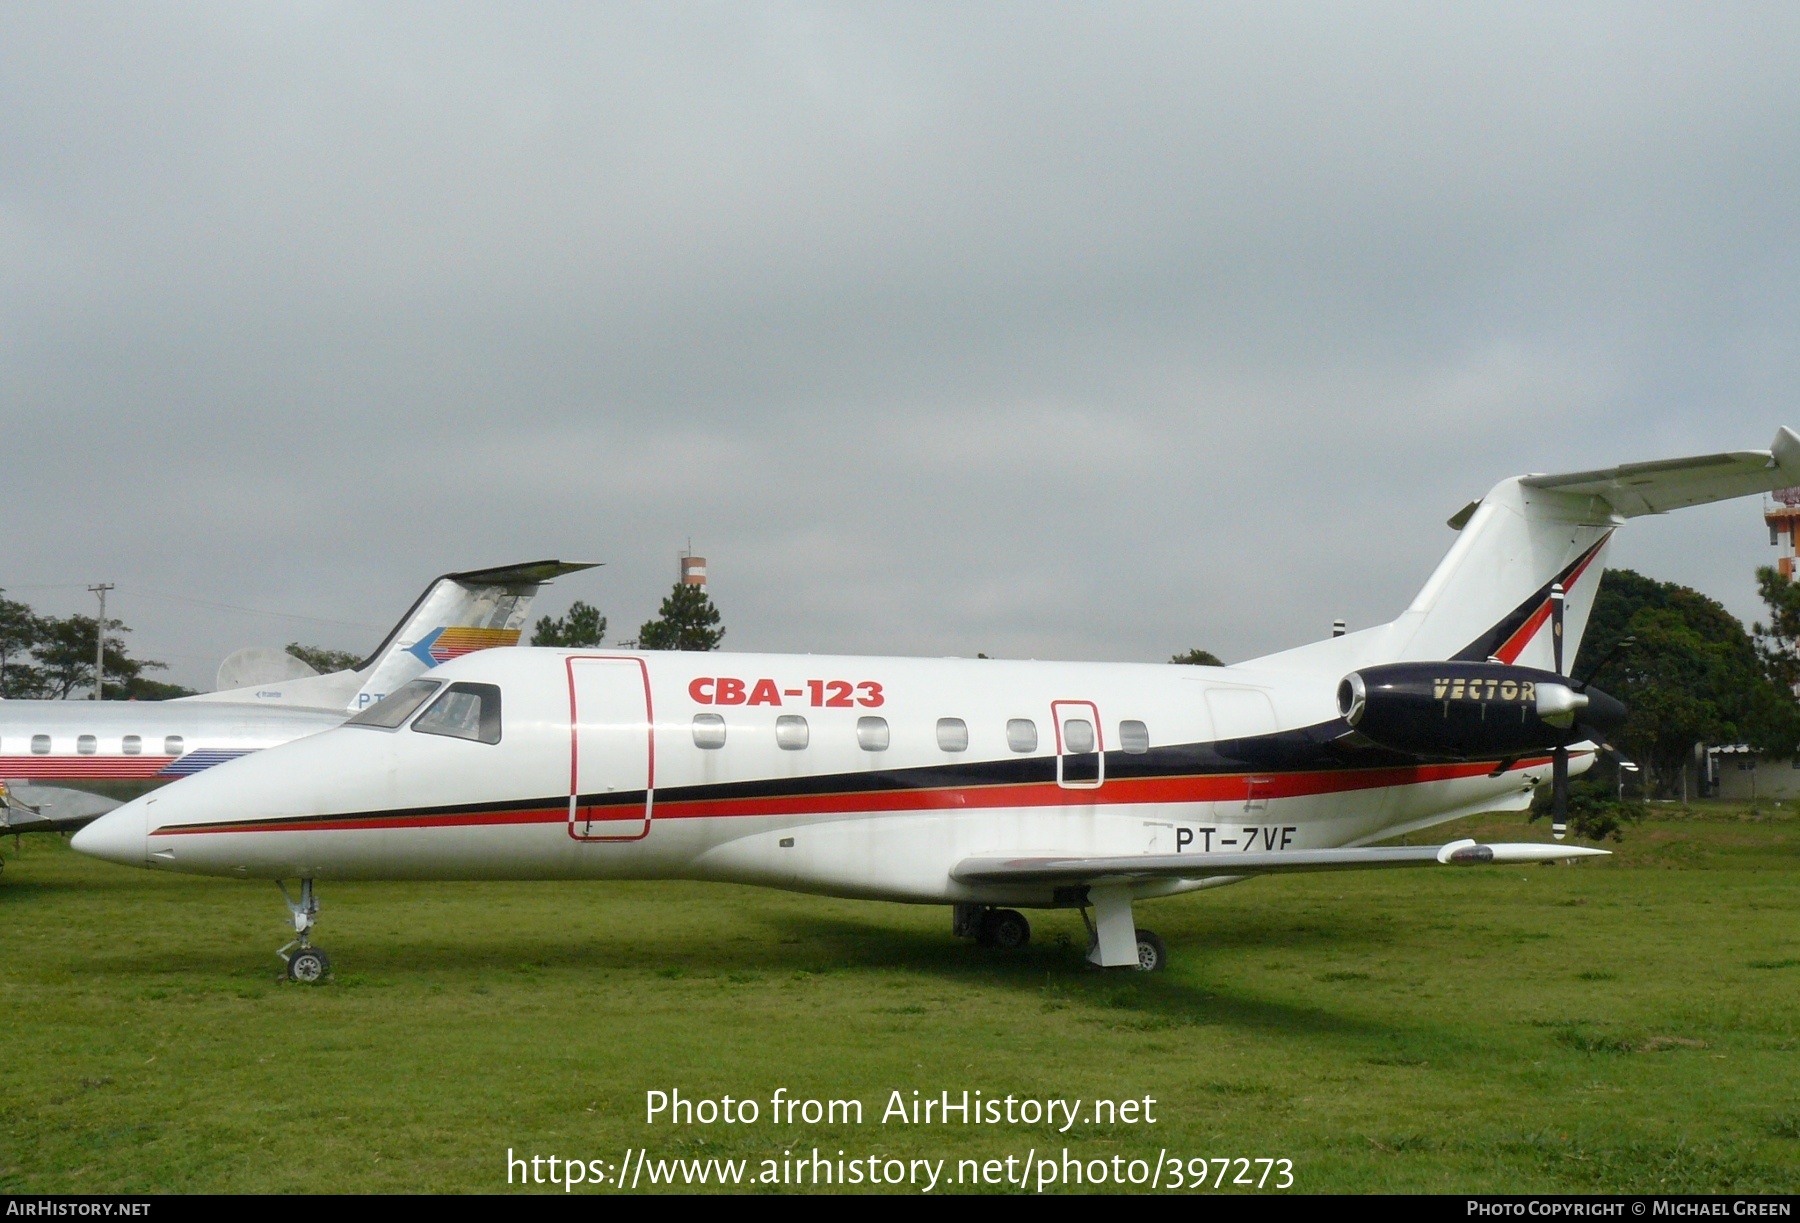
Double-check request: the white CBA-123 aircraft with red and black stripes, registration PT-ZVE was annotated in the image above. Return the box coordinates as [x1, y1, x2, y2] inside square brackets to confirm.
[74, 429, 1800, 980]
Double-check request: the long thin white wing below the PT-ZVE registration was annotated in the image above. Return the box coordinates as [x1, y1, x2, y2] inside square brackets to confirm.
[950, 841, 1609, 884]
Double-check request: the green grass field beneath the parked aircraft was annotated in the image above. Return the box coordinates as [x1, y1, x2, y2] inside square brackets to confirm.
[0, 807, 1800, 1192]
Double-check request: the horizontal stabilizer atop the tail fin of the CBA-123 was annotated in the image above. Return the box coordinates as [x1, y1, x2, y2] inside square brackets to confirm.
[1519, 429, 1800, 519]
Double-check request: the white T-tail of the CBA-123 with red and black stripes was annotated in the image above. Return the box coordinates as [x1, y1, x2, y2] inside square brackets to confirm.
[1256, 429, 1800, 670]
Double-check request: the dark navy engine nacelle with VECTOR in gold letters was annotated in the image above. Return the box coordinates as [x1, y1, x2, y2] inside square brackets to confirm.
[1337, 663, 1625, 760]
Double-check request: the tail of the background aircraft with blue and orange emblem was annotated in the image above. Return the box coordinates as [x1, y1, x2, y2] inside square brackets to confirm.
[184, 560, 594, 711]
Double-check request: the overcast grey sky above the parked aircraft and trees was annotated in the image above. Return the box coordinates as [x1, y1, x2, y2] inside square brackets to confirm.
[0, 0, 1800, 688]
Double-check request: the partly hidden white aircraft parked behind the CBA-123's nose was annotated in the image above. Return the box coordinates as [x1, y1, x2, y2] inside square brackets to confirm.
[0, 560, 592, 832]
